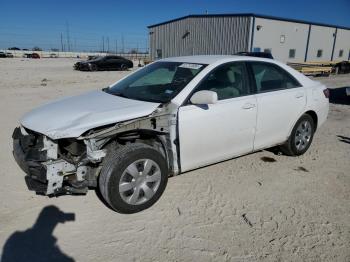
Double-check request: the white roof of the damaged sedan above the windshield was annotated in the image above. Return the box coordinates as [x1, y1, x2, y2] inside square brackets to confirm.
[158, 55, 273, 64]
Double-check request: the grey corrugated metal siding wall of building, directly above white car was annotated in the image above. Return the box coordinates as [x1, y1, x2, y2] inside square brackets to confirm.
[149, 16, 251, 59]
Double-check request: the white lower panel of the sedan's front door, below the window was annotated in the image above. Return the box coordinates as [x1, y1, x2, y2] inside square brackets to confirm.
[179, 95, 257, 172]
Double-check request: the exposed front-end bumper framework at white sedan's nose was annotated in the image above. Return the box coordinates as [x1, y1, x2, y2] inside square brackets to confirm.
[12, 127, 87, 196]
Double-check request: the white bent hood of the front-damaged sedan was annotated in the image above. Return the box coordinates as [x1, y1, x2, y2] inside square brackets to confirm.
[20, 91, 160, 139]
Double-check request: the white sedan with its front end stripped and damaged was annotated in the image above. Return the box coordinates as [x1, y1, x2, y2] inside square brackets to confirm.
[13, 56, 328, 213]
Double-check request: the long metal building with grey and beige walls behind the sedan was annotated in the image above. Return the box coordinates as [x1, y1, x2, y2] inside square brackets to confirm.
[148, 14, 350, 62]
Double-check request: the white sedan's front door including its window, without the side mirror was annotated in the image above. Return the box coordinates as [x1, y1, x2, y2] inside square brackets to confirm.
[178, 62, 256, 172]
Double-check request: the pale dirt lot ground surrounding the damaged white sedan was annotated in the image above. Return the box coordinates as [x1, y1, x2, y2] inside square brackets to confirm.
[0, 59, 350, 262]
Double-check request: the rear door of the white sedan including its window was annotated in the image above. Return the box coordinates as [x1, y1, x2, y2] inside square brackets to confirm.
[248, 62, 306, 150]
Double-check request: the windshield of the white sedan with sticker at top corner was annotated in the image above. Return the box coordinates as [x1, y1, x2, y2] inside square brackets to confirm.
[104, 62, 206, 103]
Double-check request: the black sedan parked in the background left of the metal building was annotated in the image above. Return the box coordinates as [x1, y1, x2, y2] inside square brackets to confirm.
[74, 55, 134, 71]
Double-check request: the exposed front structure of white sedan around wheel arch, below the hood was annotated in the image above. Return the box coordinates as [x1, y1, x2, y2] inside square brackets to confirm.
[12, 105, 179, 196]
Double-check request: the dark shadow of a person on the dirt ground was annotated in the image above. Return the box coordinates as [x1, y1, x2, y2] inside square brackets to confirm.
[0, 206, 75, 262]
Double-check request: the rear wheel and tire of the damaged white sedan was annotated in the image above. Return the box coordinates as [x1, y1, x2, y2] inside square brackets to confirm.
[280, 114, 315, 156]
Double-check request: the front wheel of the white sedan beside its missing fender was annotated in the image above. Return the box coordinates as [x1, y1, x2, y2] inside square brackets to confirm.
[99, 143, 168, 214]
